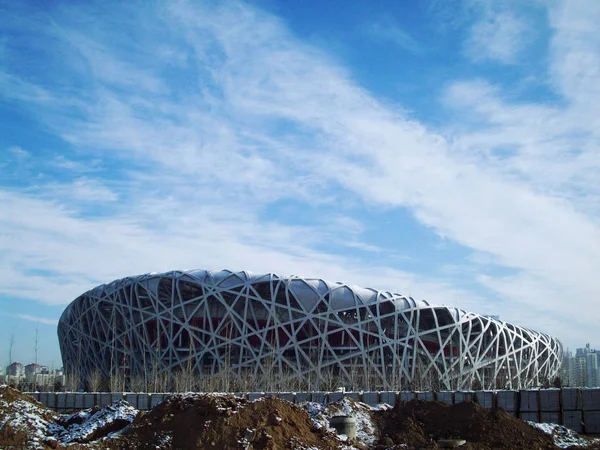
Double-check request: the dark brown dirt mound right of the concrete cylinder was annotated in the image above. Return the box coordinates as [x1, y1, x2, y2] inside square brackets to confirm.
[373, 400, 558, 450]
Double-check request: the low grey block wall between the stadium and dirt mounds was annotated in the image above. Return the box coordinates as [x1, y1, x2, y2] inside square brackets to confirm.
[29, 388, 600, 434]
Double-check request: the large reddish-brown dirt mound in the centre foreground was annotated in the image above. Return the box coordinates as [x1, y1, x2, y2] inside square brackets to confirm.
[118, 394, 339, 449]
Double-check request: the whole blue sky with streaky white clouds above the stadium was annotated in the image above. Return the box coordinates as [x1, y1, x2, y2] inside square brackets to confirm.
[0, 0, 600, 367]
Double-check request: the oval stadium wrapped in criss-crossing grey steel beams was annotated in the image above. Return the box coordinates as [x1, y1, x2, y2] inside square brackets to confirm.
[58, 270, 562, 389]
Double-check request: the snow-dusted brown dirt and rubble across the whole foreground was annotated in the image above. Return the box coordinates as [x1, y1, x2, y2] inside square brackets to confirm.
[0, 386, 600, 450]
